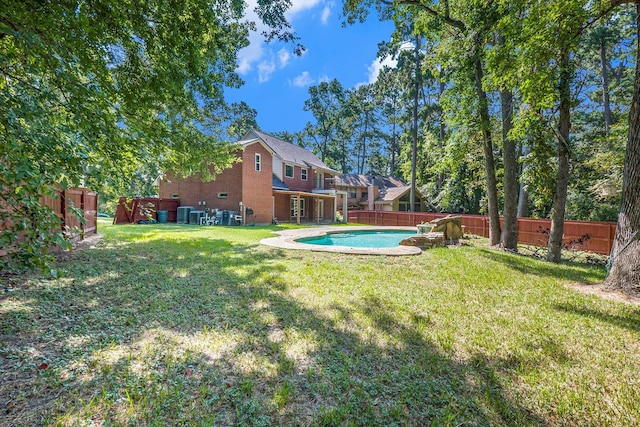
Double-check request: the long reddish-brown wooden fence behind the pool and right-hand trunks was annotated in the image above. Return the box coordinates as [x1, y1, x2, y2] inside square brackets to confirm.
[347, 211, 616, 255]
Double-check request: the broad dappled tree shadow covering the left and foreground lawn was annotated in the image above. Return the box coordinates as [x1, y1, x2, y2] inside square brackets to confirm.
[0, 232, 544, 426]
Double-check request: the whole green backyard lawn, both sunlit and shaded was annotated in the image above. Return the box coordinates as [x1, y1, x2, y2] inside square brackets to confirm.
[0, 221, 640, 426]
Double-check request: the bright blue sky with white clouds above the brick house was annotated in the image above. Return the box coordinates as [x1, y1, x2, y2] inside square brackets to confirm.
[225, 0, 393, 136]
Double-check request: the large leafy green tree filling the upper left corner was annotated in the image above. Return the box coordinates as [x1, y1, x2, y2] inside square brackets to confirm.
[0, 0, 300, 270]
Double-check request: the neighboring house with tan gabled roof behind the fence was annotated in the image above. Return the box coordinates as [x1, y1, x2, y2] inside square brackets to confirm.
[331, 174, 424, 212]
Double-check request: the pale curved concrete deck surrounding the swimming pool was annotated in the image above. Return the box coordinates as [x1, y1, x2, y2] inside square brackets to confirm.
[260, 226, 422, 256]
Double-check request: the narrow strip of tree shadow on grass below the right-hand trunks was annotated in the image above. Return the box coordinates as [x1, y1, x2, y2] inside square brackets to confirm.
[478, 248, 604, 283]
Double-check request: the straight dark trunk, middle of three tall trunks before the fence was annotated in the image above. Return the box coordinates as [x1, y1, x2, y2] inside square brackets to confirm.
[500, 90, 518, 251]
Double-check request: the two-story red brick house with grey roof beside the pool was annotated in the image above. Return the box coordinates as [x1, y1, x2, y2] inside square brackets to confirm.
[159, 129, 344, 224]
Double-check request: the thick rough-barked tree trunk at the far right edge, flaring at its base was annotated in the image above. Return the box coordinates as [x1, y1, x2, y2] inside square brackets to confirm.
[604, 4, 640, 295]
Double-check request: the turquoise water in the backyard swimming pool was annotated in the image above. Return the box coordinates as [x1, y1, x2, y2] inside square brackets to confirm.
[296, 231, 416, 248]
